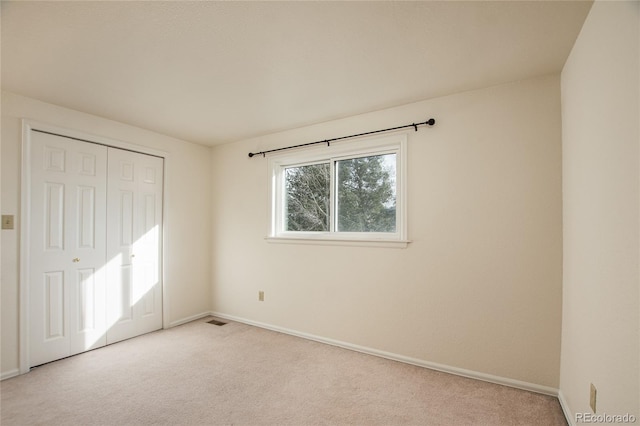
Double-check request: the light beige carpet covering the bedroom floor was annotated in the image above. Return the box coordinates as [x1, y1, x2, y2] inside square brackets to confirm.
[0, 318, 566, 426]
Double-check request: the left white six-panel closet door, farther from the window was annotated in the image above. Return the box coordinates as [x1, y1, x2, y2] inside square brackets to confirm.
[29, 131, 107, 366]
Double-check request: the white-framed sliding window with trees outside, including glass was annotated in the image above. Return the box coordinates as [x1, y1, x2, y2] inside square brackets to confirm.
[269, 135, 407, 246]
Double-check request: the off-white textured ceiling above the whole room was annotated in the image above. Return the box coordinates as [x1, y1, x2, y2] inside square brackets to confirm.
[1, 1, 591, 145]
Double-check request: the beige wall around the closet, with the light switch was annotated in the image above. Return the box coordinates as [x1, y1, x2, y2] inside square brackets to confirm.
[1, 92, 211, 376]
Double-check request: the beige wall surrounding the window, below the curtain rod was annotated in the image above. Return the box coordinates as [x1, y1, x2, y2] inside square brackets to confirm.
[211, 76, 562, 388]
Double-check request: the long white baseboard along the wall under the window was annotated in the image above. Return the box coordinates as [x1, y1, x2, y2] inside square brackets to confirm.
[210, 312, 566, 398]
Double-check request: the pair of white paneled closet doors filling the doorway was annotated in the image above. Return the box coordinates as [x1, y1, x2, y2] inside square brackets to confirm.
[21, 128, 164, 369]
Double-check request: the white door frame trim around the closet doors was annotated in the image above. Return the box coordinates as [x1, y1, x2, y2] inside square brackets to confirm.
[18, 119, 170, 374]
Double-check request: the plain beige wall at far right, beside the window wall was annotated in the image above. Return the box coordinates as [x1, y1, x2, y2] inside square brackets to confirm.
[560, 1, 640, 419]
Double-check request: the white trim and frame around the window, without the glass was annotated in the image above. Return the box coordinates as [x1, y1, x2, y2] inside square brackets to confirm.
[266, 133, 410, 248]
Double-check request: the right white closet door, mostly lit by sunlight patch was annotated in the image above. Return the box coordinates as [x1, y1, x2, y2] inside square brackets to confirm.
[107, 148, 164, 343]
